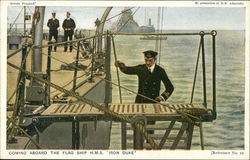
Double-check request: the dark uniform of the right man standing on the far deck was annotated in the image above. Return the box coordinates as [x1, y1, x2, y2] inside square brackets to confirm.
[62, 18, 76, 51]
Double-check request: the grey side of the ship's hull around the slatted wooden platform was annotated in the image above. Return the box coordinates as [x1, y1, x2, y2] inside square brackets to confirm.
[8, 81, 111, 149]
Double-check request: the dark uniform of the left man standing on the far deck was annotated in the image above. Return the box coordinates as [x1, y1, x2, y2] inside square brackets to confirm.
[47, 18, 59, 51]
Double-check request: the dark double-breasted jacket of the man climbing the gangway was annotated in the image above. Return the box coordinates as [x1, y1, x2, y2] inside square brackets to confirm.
[121, 64, 174, 103]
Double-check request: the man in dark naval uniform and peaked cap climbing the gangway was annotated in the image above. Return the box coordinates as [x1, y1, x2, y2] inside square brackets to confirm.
[115, 50, 174, 103]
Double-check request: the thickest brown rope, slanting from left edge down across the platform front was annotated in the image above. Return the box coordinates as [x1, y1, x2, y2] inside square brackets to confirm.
[7, 62, 158, 149]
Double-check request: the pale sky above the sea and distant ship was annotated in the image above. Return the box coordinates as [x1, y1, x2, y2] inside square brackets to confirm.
[7, 6, 245, 30]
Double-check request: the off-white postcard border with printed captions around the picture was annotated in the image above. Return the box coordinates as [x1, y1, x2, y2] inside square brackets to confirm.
[0, 1, 250, 159]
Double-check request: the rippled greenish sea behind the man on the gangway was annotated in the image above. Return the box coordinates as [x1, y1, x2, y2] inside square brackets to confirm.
[110, 30, 244, 150]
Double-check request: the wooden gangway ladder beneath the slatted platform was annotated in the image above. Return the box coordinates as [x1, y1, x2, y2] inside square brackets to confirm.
[122, 120, 194, 149]
